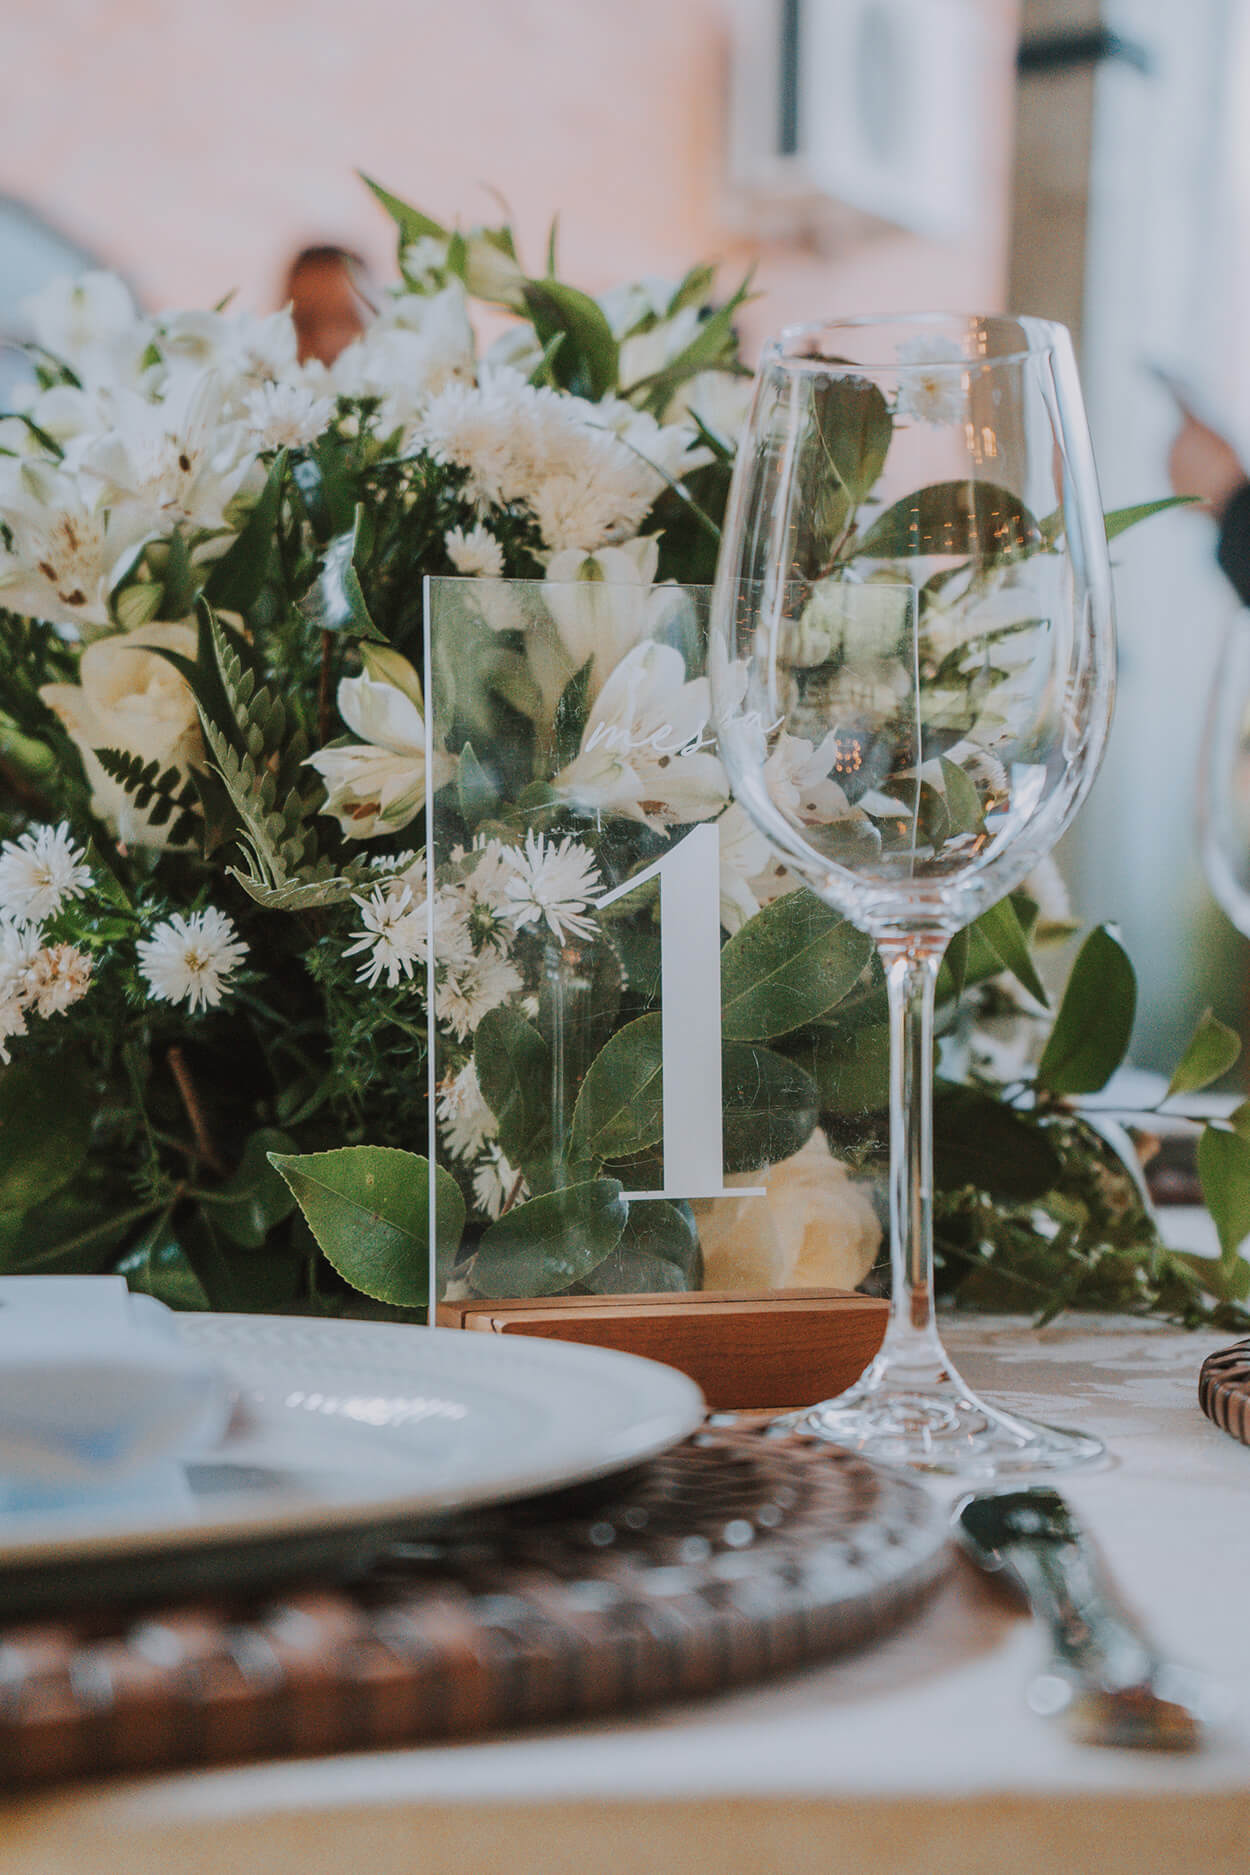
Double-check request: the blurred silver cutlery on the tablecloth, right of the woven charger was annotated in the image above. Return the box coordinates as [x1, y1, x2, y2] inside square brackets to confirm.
[952, 1485, 1224, 1751]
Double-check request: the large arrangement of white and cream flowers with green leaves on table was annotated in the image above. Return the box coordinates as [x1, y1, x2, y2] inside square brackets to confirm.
[0, 172, 1250, 1320]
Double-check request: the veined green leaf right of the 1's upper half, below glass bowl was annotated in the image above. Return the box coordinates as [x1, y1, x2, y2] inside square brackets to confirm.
[720, 893, 871, 1041]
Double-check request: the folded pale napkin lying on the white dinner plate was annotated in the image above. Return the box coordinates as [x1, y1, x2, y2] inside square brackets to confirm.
[0, 1277, 231, 1504]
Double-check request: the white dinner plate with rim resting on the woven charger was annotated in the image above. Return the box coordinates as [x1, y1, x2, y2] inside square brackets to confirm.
[0, 1314, 705, 1614]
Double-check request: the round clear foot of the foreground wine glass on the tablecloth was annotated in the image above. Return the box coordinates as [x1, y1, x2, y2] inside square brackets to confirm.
[774, 1363, 1106, 1481]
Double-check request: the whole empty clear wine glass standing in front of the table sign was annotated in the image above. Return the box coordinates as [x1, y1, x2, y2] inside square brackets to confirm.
[710, 315, 1115, 1478]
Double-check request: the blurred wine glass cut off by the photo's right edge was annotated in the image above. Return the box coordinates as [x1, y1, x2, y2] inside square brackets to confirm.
[1198, 611, 1250, 938]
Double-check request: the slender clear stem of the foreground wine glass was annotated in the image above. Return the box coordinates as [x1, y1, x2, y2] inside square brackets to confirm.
[877, 932, 948, 1367]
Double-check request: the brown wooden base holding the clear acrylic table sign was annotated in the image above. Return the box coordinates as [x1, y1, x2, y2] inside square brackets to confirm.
[439, 1290, 888, 1410]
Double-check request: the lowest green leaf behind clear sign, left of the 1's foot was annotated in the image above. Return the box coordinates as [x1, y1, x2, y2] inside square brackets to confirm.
[470, 1178, 630, 1296]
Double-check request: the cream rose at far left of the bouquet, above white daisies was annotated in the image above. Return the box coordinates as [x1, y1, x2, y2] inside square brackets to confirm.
[39, 623, 204, 848]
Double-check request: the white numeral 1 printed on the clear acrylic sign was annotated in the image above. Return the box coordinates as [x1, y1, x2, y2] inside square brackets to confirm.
[598, 825, 763, 1198]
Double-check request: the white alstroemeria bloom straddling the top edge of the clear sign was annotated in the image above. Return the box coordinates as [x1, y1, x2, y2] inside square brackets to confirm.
[543, 538, 675, 701]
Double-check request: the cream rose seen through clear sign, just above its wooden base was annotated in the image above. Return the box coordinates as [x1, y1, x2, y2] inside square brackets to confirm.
[693, 1127, 881, 1290]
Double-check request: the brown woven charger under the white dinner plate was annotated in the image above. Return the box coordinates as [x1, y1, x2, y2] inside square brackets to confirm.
[0, 1429, 948, 1785]
